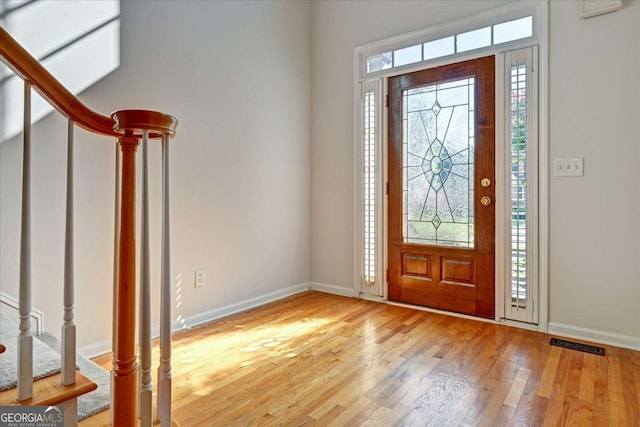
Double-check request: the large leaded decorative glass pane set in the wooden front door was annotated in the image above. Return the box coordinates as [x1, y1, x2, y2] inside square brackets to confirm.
[402, 78, 475, 248]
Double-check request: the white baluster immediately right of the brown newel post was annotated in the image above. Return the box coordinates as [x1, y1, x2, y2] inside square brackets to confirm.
[140, 130, 153, 427]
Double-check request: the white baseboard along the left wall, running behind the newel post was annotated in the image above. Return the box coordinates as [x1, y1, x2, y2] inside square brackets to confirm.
[78, 283, 310, 358]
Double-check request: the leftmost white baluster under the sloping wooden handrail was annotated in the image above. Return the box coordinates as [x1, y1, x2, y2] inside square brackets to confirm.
[18, 81, 33, 401]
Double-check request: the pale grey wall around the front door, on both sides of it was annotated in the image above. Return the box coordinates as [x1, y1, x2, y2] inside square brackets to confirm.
[311, 1, 640, 345]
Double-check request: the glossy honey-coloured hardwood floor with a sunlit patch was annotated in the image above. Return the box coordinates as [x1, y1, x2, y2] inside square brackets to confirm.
[81, 292, 640, 427]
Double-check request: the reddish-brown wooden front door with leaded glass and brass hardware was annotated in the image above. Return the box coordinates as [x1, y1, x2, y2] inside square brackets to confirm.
[388, 56, 495, 318]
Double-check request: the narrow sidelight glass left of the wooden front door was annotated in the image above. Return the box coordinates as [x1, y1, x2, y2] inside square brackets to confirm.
[363, 92, 376, 285]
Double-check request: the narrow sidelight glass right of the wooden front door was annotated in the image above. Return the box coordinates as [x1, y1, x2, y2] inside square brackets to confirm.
[510, 64, 527, 307]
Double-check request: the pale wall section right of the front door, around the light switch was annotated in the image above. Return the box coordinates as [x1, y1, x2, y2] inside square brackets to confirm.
[550, 0, 640, 339]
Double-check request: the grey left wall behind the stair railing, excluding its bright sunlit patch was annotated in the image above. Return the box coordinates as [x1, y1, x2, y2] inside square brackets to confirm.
[0, 1, 311, 345]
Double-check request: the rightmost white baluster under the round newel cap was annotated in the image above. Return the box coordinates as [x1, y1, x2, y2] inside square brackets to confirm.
[158, 135, 171, 427]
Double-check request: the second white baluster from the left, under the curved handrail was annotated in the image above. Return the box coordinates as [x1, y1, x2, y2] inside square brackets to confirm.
[61, 119, 76, 385]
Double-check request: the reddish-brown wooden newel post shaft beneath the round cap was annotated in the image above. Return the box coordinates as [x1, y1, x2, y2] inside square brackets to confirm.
[112, 131, 140, 427]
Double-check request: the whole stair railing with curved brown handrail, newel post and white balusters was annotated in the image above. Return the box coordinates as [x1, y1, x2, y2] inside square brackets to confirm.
[0, 27, 177, 427]
